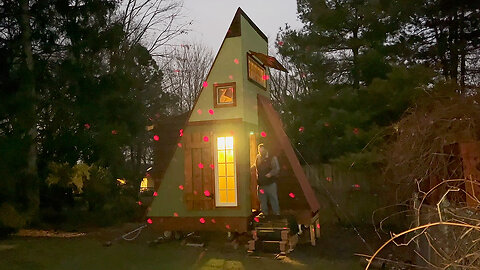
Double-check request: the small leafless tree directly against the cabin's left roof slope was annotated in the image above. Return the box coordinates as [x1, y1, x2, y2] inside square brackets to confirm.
[159, 43, 213, 113]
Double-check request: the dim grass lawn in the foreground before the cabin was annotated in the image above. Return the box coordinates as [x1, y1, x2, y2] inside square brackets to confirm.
[0, 226, 363, 270]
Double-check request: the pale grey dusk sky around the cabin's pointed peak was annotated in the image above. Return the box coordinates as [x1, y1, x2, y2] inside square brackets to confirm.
[178, 0, 302, 52]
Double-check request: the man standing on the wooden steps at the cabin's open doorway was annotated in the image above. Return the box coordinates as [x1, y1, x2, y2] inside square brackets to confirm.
[255, 143, 280, 215]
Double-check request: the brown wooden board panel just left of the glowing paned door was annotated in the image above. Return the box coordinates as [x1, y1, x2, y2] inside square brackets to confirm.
[183, 132, 215, 210]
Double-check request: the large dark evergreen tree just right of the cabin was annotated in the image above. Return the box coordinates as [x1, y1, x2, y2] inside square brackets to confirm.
[277, 0, 433, 166]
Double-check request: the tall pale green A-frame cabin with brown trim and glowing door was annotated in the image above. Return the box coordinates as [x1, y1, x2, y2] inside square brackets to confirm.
[147, 8, 319, 238]
